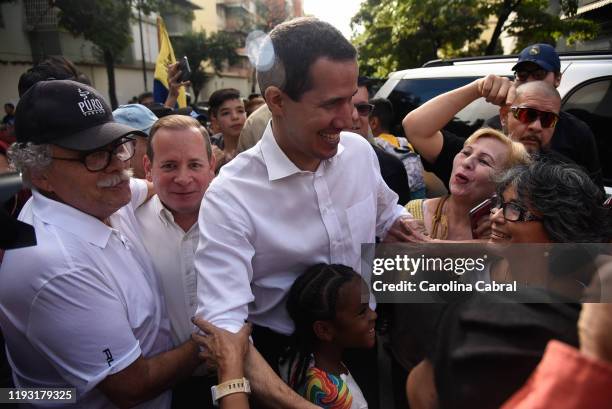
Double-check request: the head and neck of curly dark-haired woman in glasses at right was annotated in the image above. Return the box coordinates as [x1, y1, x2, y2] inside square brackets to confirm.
[490, 160, 612, 290]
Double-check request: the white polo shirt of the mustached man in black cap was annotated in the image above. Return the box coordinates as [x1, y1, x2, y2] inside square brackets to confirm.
[0, 180, 172, 409]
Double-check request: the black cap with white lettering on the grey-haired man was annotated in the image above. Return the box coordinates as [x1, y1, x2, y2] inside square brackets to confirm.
[15, 80, 147, 151]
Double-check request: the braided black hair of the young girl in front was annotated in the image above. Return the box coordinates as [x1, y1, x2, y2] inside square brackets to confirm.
[286, 263, 361, 390]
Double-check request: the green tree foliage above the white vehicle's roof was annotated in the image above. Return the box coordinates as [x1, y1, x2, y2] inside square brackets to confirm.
[352, 0, 597, 77]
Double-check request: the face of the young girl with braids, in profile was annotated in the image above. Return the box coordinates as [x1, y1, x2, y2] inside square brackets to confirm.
[333, 278, 376, 348]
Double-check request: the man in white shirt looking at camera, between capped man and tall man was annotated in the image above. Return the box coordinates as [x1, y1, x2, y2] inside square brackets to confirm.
[136, 115, 215, 408]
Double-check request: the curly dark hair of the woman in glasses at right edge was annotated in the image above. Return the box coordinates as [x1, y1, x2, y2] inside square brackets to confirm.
[497, 158, 612, 243]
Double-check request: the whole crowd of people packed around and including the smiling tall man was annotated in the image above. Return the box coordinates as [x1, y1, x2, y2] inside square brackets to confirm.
[0, 18, 612, 409]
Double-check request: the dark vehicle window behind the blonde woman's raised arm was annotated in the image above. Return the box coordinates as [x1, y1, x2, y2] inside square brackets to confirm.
[387, 77, 499, 138]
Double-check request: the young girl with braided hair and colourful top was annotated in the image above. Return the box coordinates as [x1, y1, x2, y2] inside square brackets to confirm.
[283, 264, 376, 409]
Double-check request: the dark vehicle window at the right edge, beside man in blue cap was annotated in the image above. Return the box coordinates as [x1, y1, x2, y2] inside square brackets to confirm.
[562, 77, 612, 186]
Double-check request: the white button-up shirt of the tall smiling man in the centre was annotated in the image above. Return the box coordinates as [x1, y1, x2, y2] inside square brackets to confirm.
[195, 124, 405, 334]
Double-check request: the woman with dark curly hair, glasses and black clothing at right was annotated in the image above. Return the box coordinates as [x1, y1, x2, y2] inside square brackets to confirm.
[406, 160, 612, 409]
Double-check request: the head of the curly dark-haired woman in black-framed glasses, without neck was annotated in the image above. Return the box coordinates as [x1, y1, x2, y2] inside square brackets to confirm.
[491, 160, 612, 243]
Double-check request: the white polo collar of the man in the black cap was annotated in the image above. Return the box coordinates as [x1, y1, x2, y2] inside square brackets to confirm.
[32, 189, 113, 248]
